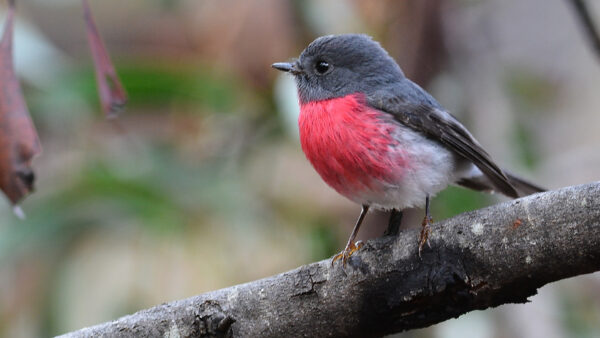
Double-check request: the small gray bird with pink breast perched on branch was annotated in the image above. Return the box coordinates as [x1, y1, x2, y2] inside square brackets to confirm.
[272, 34, 544, 266]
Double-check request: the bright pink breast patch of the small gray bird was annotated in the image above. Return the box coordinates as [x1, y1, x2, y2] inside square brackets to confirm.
[298, 94, 404, 199]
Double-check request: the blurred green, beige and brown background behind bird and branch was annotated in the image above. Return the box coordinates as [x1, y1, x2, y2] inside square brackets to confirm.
[0, 0, 600, 337]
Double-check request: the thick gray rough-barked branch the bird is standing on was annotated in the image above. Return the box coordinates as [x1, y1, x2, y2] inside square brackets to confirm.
[58, 182, 600, 337]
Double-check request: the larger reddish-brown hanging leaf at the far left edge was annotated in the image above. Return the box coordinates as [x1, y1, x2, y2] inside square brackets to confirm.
[0, 1, 41, 204]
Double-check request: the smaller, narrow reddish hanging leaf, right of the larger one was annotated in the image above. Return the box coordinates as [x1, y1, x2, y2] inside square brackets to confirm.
[82, 0, 127, 118]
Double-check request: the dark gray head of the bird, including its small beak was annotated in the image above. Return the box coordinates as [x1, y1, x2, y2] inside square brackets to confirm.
[273, 34, 404, 103]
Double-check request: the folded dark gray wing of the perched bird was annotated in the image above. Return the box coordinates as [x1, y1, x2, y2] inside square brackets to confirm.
[368, 86, 518, 198]
